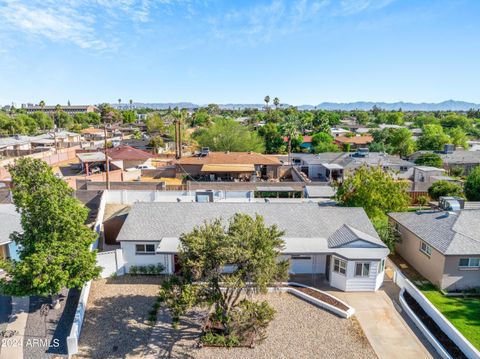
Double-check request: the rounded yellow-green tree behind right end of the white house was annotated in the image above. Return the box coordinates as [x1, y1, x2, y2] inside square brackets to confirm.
[336, 166, 410, 218]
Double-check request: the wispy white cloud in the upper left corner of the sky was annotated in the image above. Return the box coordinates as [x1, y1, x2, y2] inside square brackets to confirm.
[0, 0, 189, 50]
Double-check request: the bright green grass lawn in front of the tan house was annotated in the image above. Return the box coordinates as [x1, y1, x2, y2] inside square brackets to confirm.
[418, 284, 480, 350]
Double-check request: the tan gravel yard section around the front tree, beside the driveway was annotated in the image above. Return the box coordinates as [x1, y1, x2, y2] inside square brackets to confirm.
[146, 293, 377, 359]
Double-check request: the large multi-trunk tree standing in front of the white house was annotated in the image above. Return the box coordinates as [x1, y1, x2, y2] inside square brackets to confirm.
[163, 213, 288, 346]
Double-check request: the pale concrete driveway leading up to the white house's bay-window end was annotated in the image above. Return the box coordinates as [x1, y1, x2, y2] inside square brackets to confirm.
[329, 282, 437, 359]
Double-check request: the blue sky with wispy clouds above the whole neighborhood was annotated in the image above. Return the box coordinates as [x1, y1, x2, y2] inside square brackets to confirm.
[0, 0, 480, 105]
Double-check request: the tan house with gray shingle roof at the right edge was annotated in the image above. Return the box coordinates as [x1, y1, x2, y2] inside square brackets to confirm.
[389, 210, 480, 291]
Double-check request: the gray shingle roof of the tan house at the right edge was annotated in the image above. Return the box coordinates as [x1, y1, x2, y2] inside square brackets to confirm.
[389, 210, 480, 255]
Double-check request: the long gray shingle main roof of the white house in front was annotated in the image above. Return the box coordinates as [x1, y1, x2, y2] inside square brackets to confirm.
[117, 202, 384, 246]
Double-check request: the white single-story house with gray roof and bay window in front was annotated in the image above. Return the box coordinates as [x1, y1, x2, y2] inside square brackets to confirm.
[117, 202, 389, 291]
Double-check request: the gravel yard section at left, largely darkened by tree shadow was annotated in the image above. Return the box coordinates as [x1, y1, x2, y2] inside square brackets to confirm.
[75, 276, 162, 359]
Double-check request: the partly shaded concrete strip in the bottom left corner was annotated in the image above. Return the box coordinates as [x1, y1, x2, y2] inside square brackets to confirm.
[0, 297, 30, 359]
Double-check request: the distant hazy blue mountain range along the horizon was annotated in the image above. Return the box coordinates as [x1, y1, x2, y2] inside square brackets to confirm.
[112, 100, 480, 111]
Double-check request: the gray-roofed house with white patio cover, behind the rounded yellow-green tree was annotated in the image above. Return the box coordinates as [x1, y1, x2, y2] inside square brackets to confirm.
[292, 150, 414, 182]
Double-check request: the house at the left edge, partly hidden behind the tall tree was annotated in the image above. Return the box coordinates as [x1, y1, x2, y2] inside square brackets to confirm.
[0, 204, 22, 260]
